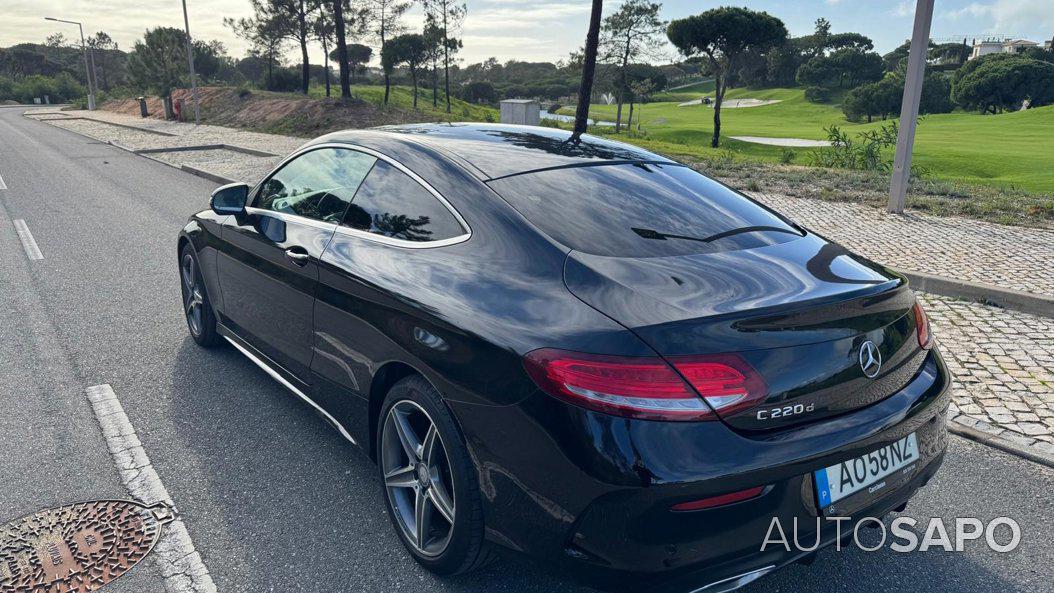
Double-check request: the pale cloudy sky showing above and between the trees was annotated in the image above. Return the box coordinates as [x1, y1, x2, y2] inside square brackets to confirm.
[0, 0, 1054, 63]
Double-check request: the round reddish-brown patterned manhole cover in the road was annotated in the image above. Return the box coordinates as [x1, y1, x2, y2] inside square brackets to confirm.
[0, 500, 173, 593]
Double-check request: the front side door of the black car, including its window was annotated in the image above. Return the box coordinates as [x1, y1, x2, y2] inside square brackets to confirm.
[217, 146, 375, 384]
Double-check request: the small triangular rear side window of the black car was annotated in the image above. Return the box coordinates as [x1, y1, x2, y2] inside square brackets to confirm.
[344, 160, 465, 241]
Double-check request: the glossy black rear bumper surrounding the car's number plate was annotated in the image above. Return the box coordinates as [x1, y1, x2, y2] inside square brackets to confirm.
[453, 351, 950, 592]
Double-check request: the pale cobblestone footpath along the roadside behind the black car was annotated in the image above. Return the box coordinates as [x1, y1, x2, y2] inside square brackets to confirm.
[27, 110, 1054, 464]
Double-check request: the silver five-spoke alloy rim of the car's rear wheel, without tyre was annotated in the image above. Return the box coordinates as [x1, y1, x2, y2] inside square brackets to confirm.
[380, 399, 456, 557]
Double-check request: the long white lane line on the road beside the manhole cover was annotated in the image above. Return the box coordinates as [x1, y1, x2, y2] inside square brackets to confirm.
[85, 384, 217, 593]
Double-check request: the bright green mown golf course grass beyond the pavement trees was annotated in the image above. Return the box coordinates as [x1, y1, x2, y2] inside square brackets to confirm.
[556, 88, 1054, 195]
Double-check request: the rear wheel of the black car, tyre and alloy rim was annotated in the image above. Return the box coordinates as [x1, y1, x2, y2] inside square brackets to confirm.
[376, 375, 494, 575]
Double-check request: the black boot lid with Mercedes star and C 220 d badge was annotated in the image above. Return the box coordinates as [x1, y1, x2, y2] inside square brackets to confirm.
[564, 234, 925, 431]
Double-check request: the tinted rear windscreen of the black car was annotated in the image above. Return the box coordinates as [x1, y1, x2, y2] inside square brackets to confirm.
[490, 164, 801, 257]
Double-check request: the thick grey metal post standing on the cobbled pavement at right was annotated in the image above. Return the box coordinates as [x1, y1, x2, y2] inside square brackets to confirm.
[886, 0, 934, 214]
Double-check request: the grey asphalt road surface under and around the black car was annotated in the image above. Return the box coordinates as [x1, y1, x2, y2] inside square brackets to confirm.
[0, 108, 1054, 593]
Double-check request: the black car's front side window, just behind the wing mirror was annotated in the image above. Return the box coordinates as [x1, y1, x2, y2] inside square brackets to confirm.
[253, 149, 376, 223]
